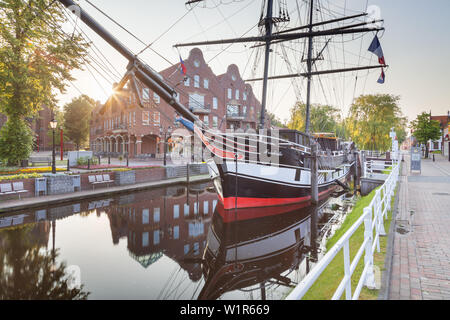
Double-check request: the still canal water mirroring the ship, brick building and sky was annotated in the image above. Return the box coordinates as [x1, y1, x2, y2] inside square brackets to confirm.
[0, 184, 352, 300]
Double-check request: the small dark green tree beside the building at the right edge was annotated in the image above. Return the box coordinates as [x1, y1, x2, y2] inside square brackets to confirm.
[410, 112, 441, 158]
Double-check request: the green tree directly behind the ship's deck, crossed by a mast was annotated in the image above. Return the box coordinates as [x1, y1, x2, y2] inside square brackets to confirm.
[287, 102, 340, 133]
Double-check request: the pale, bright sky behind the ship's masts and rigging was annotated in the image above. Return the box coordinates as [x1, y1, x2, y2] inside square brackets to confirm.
[59, 0, 450, 124]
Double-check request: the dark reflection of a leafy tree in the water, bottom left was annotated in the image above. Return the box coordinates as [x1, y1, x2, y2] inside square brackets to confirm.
[0, 222, 89, 300]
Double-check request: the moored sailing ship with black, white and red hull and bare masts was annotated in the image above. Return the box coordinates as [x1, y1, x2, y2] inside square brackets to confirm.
[55, 0, 386, 215]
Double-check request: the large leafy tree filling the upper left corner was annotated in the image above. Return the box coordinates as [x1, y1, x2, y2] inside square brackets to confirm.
[0, 0, 88, 164]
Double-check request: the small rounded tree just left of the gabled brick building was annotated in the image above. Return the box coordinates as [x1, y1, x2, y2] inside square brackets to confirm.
[64, 95, 95, 150]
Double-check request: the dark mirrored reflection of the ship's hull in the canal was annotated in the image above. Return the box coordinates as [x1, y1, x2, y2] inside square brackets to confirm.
[198, 200, 319, 300]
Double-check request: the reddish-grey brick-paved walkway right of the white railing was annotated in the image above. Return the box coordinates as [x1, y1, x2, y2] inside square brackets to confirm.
[389, 155, 450, 300]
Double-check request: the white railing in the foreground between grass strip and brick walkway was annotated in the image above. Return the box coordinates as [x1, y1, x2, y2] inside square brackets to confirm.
[286, 161, 399, 300]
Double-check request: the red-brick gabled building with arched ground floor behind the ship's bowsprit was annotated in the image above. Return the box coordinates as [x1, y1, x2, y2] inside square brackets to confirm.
[90, 48, 261, 158]
